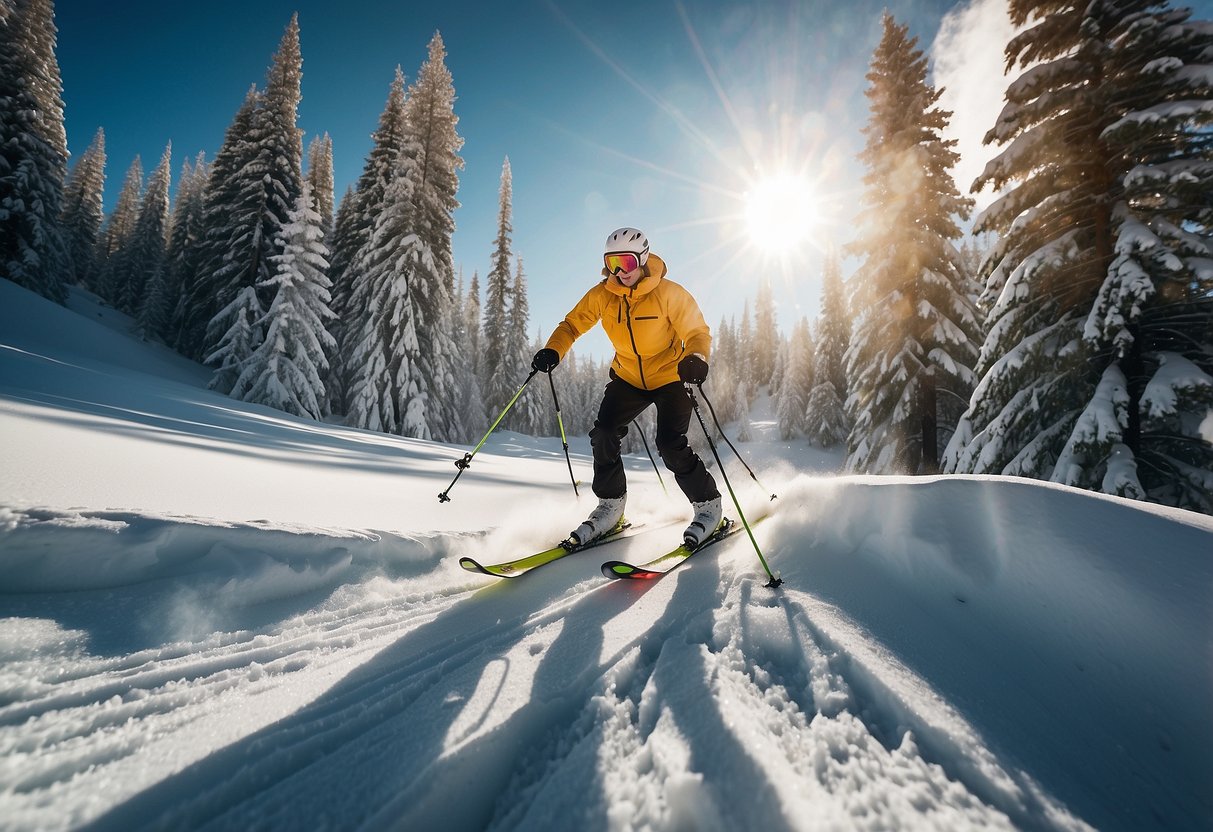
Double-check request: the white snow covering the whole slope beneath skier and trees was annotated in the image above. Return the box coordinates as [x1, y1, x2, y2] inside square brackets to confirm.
[0, 281, 1213, 830]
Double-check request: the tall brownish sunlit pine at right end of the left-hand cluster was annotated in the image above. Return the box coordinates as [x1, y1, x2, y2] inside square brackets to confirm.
[400, 32, 471, 441]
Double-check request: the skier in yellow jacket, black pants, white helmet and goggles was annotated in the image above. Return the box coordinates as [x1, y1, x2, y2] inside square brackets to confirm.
[531, 228, 721, 547]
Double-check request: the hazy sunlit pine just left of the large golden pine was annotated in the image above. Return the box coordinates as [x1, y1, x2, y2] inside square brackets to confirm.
[804, 250, 850, 448]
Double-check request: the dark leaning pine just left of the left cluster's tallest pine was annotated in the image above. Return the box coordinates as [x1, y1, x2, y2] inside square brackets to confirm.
[175, 86, 261, 359]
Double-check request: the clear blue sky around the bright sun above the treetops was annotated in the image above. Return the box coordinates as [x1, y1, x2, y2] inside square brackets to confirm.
[56, 0, 984, 354]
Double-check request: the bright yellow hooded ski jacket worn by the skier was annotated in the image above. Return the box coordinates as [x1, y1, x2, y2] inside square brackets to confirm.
[546, 253, 712, 391]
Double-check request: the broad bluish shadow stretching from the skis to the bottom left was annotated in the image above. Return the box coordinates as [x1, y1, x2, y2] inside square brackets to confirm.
[86, 550, 682, 830]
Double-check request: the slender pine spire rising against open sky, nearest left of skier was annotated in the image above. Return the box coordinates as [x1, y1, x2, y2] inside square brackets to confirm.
[480, 156, 514, 421]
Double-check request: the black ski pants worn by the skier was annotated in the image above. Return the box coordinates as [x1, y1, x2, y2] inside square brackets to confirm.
[590, 372, 721, 502]
